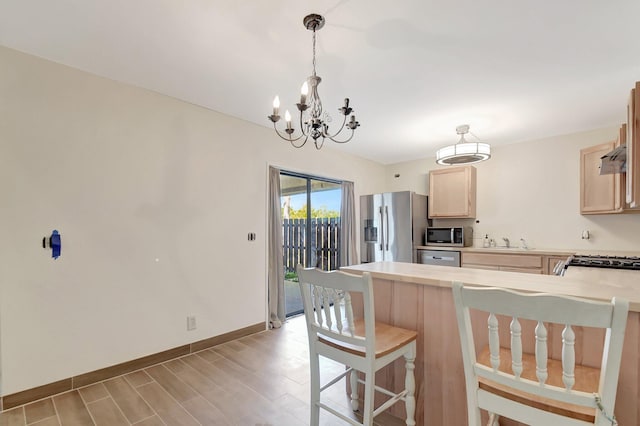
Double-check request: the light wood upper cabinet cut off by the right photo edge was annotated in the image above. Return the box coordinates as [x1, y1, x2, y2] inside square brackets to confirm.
[626, 82, 640, 209]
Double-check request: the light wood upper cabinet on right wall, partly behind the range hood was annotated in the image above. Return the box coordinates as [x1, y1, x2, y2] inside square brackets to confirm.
[580, 138, 624, 214]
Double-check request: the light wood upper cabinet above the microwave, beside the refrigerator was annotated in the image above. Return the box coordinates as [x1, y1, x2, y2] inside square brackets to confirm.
[429, 166, 476, 218]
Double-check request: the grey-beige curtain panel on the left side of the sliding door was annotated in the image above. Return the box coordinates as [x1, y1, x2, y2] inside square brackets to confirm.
[267, 167, 286, 328]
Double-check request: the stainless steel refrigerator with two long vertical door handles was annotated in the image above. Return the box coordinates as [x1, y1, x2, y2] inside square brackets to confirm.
[360, 191, 427, 263]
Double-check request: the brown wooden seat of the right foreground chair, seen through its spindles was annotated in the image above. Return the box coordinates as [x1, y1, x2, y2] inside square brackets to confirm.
[477, 346, 600, 423]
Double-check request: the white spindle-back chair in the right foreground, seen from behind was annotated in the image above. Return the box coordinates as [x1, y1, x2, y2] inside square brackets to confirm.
[453, 283, 629, 426]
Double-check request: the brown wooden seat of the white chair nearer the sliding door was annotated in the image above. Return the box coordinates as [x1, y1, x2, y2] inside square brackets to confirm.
[318, 319, 418, 358]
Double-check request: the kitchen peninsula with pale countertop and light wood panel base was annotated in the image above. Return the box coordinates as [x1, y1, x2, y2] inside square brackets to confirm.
[341, 262, 640, 425]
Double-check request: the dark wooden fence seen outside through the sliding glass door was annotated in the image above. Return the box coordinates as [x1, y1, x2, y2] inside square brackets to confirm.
[282, 217, 340, 272]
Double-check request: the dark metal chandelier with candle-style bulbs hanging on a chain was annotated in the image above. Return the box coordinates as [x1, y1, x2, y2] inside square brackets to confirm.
[268, 13, 360, 149]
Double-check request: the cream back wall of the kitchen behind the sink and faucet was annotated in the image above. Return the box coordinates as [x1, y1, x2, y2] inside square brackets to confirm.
[385, 128, 640, 254]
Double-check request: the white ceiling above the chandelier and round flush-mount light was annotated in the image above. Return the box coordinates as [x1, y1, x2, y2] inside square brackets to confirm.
[0, 0, 640, 164]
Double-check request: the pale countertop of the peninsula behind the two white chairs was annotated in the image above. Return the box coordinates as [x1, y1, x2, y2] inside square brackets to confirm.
[340, 260, 640, 312]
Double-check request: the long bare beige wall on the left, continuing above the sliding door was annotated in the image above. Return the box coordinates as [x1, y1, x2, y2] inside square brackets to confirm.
[0, 47, 384, 395]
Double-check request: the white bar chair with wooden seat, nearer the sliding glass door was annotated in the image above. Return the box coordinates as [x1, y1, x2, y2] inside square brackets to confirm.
[298, 265, 417, 426]
